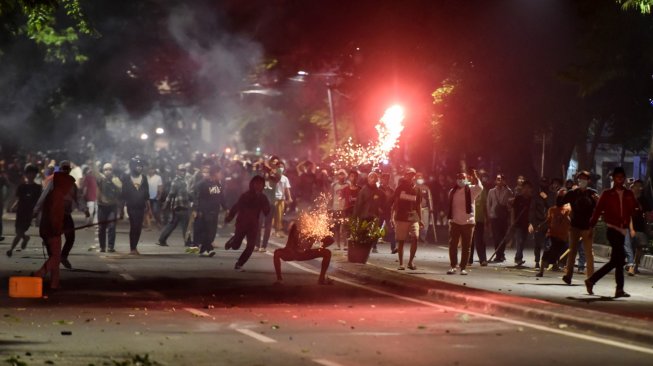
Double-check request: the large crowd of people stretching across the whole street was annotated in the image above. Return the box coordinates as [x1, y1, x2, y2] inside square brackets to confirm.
[0, 147, 652, 296]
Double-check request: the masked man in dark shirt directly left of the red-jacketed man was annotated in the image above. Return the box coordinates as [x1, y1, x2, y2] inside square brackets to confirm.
[562, 170, 599, 285]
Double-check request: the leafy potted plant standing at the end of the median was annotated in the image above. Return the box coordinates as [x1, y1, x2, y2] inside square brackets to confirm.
[347, 218, 385, 263]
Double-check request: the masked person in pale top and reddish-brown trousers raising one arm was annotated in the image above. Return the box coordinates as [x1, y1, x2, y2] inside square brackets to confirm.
[447, 170, 483, 275]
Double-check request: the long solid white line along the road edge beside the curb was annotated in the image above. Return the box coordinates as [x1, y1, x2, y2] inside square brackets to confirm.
[288, 262, 653, 355]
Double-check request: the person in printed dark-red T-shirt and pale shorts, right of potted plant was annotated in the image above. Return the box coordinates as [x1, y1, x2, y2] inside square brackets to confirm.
[391, 168, 422, 271]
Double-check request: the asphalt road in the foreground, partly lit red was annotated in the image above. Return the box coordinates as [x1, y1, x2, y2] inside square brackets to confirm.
[0, 219, 653, 366]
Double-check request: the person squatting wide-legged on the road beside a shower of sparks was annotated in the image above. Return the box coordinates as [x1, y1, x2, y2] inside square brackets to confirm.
[273, 222, 335, 285]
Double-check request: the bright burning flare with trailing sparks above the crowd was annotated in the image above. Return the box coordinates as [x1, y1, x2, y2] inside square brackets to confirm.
[331, 105, 405, 169]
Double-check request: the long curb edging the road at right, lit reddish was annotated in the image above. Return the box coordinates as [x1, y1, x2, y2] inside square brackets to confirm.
[334, 262, 653, 344]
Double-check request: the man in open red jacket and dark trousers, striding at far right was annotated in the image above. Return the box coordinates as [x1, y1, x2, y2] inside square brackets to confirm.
[585, 167, 637, 298]
